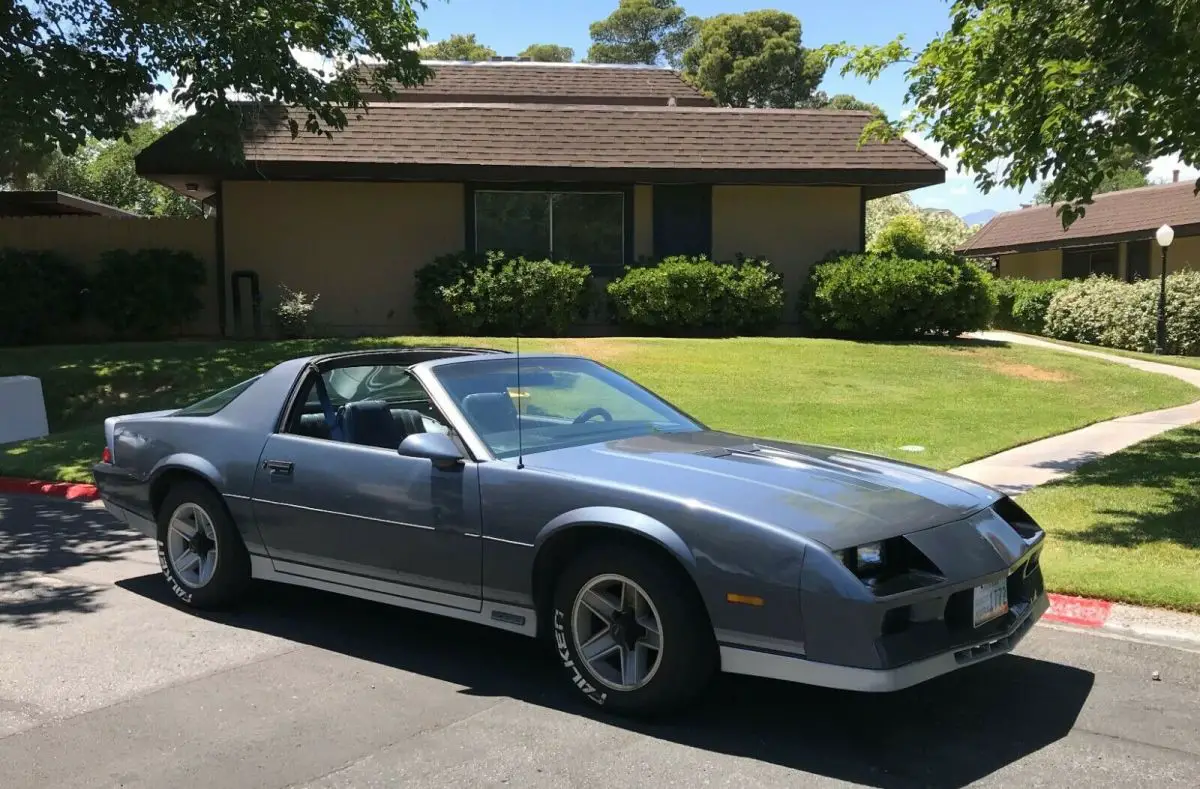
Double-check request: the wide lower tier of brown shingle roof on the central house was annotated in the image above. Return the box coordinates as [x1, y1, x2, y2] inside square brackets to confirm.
[231, 103, 944, 172]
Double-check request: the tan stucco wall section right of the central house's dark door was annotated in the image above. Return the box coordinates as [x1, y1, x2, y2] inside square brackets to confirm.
[713, 186, 862, 306]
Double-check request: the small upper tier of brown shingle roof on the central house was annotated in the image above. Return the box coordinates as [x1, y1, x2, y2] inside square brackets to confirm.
[360, 61, 713, 107]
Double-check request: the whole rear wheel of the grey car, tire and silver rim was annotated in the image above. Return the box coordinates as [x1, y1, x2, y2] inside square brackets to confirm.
[157, 482, 250, 608]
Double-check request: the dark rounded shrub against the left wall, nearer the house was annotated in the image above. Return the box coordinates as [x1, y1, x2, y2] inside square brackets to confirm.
[90, 249, 208, 339]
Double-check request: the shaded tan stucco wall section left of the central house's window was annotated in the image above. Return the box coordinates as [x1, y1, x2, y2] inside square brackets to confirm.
[223, 182, 463, 335]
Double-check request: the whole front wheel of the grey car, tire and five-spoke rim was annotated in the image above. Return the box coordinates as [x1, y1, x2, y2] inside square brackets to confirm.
[553, 546, 718, 716]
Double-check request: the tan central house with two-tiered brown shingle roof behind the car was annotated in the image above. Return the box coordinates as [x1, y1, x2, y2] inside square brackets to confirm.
[137, 61, 946, 332]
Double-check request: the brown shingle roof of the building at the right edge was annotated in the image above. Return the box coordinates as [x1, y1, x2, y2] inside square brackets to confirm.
[962, 181, 1200, 255]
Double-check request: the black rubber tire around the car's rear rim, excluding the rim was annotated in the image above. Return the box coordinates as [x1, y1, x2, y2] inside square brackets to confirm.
[156, 482, 250, 609]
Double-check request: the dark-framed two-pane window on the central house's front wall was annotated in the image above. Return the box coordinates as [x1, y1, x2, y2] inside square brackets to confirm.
[475, 189, 625, 275]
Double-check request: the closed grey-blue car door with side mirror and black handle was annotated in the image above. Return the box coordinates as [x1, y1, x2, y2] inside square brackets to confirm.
[252, 364, 482, 610]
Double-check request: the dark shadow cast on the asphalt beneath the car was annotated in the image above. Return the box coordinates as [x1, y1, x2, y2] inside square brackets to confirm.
[118, 574, 1093, 789]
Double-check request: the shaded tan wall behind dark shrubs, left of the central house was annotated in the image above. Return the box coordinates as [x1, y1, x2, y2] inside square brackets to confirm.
[0, 216, 217, 336]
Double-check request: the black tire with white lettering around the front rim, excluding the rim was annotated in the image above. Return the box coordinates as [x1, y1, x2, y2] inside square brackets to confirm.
[551, 543, 719, 717]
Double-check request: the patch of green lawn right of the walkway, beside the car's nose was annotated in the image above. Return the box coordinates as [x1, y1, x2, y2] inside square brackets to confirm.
[1018, 426, 1200, 613]
